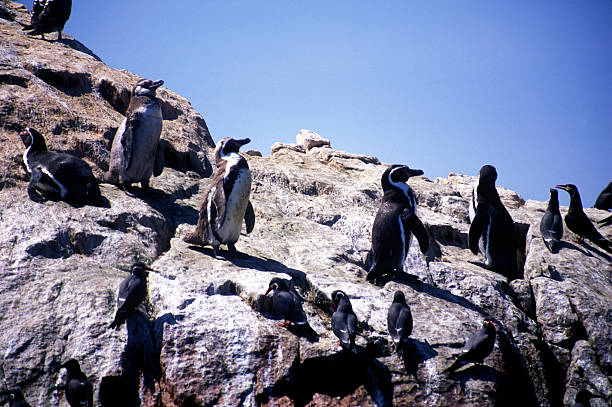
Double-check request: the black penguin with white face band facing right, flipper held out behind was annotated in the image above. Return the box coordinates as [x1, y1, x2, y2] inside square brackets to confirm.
[366, 164, 429, 281]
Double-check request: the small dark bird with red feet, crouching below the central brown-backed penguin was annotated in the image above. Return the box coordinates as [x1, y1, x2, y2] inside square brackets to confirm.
[264, 277, 318, 341]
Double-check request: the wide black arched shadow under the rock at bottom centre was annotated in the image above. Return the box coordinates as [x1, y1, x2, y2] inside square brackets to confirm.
[255, 350, 393, 407]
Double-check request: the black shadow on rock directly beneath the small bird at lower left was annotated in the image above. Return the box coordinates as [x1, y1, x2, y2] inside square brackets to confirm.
[99, 311, 178, 407]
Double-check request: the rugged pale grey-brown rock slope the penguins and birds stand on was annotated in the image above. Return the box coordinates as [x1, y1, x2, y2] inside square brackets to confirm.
[0, 3, 612, 407]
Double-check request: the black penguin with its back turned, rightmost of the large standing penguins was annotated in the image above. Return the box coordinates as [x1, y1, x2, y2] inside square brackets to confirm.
[468, 165, 520, 279]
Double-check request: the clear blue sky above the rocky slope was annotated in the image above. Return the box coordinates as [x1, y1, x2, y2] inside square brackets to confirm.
[17, 0, 612, 206]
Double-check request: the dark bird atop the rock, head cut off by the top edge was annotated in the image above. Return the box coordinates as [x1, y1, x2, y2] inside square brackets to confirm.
[23, 0, 72, 41]
